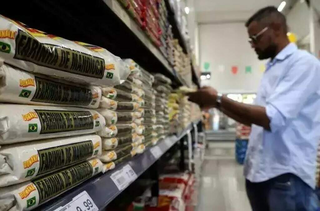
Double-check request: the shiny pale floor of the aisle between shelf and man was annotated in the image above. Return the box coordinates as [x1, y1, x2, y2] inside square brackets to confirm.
[197, 143, 251, 211]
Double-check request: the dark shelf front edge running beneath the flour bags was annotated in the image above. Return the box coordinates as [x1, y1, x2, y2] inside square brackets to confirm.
[36, 121, 198, 211]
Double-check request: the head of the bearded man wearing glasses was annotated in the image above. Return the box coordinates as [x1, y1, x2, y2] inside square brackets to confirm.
[246, 6, 289, 60]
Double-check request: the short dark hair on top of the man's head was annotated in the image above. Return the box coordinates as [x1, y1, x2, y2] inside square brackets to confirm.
[246, 6, 288, 32]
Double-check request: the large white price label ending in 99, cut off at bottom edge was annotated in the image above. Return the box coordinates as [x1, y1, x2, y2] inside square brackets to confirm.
[55, 191, 99, 211]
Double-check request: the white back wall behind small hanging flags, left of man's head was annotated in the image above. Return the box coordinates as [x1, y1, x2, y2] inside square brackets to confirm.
[199, 23, 266, 93]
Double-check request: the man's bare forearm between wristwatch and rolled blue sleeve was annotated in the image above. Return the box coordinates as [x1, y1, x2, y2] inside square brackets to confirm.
[220, 96, 270, 130]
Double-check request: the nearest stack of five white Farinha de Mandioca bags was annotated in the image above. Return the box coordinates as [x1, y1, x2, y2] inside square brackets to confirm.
[0, 16, 138, 211]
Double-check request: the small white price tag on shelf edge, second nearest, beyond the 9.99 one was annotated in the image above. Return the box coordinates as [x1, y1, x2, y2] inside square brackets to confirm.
[110, 164, 137, 190]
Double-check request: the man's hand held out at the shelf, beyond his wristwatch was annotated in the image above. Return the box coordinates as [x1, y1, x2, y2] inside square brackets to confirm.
[187, 86, 218, 109]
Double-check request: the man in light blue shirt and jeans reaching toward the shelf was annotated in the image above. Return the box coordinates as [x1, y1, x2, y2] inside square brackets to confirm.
[189, 7, 320, 211]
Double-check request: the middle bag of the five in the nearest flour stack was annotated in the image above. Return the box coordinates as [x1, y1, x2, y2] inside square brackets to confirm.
[0, 104, 106, 145]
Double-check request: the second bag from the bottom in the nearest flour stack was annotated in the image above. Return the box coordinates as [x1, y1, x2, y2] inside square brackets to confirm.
[0, 135, 102, 187]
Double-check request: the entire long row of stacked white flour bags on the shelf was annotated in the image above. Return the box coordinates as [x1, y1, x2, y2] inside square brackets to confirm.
[0, 12, 201, 211]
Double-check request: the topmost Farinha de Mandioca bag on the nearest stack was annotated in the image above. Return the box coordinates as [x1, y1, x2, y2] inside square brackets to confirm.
[0, 16, 129, 86]
